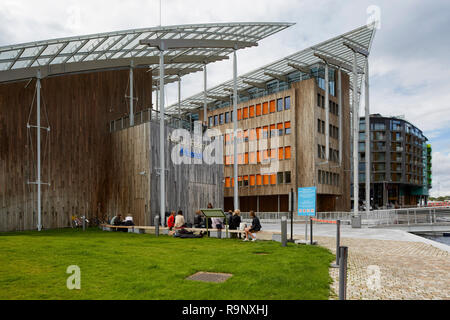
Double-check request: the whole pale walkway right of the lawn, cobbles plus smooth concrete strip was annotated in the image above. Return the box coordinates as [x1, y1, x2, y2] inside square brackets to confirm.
[263, 224, 450, 300]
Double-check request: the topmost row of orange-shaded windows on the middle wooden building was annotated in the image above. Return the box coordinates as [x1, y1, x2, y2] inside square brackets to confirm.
[208, 97, 291, 127]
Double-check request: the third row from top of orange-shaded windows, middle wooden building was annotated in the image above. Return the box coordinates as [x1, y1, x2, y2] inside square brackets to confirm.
[224, 147, 291, 165]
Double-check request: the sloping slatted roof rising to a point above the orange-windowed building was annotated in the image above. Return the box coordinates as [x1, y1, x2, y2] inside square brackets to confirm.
[167, 24, 376, 113]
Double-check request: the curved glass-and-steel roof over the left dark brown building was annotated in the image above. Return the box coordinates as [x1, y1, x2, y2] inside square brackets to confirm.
[0, 22, 293, 83]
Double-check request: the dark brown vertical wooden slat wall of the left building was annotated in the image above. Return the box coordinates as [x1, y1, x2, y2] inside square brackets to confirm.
[0, 69, 151, 231]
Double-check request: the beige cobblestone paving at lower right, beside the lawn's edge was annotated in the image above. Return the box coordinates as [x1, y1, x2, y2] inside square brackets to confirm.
[258, 232, 450, 300]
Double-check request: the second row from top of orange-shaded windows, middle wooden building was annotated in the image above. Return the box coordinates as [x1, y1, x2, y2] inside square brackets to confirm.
[225, 121, 291, 144]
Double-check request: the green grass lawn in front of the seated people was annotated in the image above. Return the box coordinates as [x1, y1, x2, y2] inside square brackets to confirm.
[0, 229, 333, 300]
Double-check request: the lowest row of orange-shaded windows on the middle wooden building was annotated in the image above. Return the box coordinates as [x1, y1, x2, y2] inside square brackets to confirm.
[225, 171, 291, 188]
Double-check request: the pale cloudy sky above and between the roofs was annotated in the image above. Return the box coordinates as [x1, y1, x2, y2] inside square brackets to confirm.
[0, 0, 450, 196]
